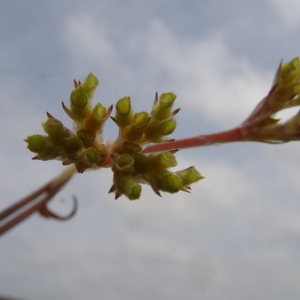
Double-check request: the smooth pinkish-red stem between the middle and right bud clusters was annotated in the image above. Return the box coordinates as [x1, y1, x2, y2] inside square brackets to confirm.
[143, 127, 245, 153]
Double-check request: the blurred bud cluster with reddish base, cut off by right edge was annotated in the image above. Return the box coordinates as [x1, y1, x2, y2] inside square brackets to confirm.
[243, 57, 300, 143]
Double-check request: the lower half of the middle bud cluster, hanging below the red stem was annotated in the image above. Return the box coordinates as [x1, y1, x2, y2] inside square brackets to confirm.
[109, 147, 203, 200]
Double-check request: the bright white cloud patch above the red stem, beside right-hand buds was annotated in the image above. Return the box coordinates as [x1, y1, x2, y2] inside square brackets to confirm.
[144, 20, 277, 125]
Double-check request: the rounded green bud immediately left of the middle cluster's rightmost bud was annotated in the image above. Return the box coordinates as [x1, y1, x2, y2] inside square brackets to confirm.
[154, 171, 183, 194]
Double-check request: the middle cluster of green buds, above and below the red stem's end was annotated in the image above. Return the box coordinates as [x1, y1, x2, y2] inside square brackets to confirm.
[110, 93, 203, 200]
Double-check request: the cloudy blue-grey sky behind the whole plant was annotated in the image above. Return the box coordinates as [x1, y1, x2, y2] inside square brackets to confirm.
[0, 0, 300, 300]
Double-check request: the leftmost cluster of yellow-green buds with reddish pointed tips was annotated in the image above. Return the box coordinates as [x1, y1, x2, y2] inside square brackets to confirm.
[26, 73, 112, 173]
